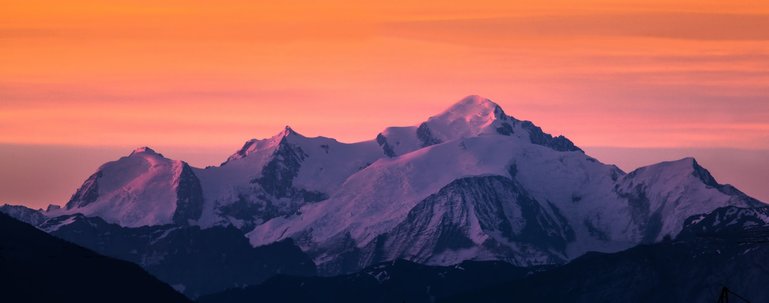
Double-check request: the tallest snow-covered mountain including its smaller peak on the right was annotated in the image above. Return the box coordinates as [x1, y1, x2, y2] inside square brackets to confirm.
[248, 97, 760, 272]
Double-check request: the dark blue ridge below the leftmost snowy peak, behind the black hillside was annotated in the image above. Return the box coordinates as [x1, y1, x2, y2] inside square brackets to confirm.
[39, 214, 316, 299]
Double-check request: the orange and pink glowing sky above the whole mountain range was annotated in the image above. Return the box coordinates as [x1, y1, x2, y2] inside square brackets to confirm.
[0, 0, 769, 208]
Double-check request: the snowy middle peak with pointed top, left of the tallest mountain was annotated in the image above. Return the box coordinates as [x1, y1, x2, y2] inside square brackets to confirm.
[196, 127, 385, 228]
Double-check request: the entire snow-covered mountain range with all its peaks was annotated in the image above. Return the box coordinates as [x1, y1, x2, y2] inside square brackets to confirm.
[22, 96, 763, 273]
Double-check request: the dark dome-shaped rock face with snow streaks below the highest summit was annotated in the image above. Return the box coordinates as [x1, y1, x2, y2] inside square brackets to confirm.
[308, 176, 574, 272]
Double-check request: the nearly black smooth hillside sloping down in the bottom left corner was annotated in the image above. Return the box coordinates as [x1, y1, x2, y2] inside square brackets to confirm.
[0, 214, 190, 303]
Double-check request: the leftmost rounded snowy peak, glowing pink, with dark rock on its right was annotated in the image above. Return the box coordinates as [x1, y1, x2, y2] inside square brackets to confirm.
[56, 147, 202, 227]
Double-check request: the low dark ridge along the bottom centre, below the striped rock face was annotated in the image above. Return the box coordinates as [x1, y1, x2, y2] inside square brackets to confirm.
[199, 260, 541, 303]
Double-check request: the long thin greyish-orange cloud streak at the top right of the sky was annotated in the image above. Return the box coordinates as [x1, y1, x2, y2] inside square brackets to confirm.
[385, 12, 769, 45]
